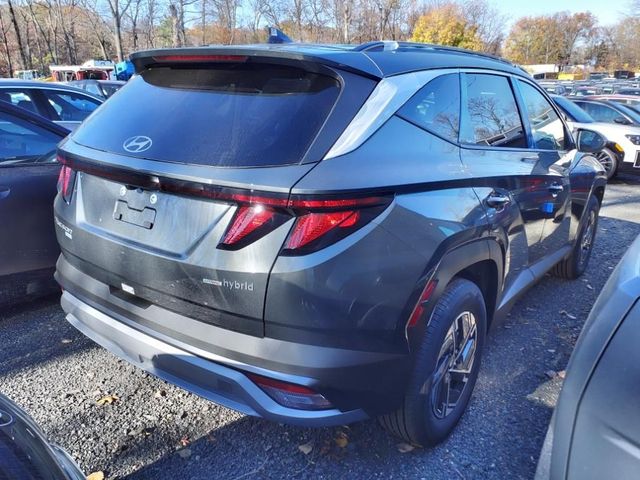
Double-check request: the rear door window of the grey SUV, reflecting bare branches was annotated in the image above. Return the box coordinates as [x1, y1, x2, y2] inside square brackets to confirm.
[461, 73, 527, 148]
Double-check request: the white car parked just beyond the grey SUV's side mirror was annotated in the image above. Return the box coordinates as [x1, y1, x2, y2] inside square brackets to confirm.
[551, 95, 640, 179]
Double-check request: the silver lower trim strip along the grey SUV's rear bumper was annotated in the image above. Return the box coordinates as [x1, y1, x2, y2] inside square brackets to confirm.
[61, 292, 367, 426]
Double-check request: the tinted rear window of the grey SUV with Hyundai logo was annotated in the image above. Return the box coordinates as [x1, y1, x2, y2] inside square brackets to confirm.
[73, 63, 340, 167]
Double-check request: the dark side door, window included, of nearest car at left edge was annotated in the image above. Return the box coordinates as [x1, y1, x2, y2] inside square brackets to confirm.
[0, 107, 63, 276]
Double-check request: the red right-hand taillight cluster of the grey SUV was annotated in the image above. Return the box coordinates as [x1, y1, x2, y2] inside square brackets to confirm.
[218, 194, 391, 256]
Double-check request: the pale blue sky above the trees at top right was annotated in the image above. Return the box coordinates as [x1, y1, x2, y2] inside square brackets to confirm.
[490, 0, 629, 26]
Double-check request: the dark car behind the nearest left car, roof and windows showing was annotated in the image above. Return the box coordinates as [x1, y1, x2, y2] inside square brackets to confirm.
[0, 79, 104, 130]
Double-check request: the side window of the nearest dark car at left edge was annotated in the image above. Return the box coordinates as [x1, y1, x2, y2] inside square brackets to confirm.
[0, 112, 61, 168]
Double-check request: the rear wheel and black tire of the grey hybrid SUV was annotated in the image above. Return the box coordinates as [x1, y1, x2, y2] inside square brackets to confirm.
[380, 278, 487, 446]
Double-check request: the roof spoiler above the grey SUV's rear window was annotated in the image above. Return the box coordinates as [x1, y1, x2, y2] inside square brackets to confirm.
[130, 43, 382, 80]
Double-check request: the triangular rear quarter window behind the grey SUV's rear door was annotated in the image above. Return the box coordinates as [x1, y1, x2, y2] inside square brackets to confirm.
[397, 73, 460, 143]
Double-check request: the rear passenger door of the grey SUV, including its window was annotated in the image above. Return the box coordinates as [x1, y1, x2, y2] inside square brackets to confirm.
[460, 73, 549, 272]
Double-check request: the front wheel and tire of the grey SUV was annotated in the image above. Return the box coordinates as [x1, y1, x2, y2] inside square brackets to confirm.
[552, 195, 600, 280]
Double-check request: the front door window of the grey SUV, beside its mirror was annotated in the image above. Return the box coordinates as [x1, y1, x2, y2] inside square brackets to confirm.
[518, 80, 565, 150]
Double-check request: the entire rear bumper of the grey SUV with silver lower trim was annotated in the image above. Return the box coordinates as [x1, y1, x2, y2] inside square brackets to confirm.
[55, 255, 410, 426]
